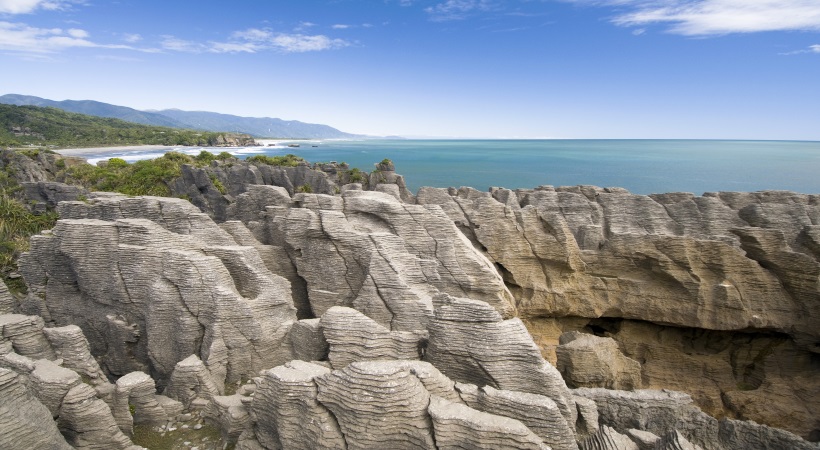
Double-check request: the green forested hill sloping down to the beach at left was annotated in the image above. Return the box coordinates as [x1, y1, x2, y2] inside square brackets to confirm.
[0, 104, 254, 148]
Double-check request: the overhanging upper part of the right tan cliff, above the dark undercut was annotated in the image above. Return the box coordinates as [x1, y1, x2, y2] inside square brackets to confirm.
[418, 186, 820, 342]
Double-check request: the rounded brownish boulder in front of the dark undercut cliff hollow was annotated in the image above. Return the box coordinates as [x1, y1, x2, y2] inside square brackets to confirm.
[556, 331, 641, 390]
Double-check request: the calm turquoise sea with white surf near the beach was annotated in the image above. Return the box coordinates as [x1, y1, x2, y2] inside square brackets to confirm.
[80, 140, 820, 195]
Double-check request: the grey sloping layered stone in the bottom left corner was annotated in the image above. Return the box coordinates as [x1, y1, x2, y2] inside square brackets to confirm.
[0, 368, 72, 450]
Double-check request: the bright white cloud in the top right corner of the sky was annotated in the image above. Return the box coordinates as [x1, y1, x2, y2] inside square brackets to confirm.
[569, 0, 820, 36]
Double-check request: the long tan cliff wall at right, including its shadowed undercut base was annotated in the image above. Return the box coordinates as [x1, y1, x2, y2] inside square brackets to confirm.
[417, 186, 820, 437]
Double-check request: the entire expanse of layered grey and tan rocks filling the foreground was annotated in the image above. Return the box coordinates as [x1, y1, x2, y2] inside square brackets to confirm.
[0, 153, 820, 450]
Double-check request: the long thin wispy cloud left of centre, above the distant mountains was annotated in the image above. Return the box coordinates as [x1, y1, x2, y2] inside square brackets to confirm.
[162, 28, 351, 53]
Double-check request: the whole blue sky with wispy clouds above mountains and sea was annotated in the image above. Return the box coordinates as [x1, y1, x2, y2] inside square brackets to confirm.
[0, 0, 820, 140]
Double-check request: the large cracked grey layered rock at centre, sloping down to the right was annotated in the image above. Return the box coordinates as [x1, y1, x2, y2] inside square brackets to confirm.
[263, 190, 514, 322]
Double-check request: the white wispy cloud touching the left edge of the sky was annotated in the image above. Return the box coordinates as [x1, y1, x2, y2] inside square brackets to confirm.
[0, 22, 131, 55]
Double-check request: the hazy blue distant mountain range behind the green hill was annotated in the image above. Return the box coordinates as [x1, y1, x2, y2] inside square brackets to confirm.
[0, 94, 366, 139]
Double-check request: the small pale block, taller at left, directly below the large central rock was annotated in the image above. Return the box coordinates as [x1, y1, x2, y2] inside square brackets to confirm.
[321, 306, 426, 369]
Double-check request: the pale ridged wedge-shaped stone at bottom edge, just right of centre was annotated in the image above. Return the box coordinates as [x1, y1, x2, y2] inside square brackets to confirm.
[428, 395, 550, 450]
